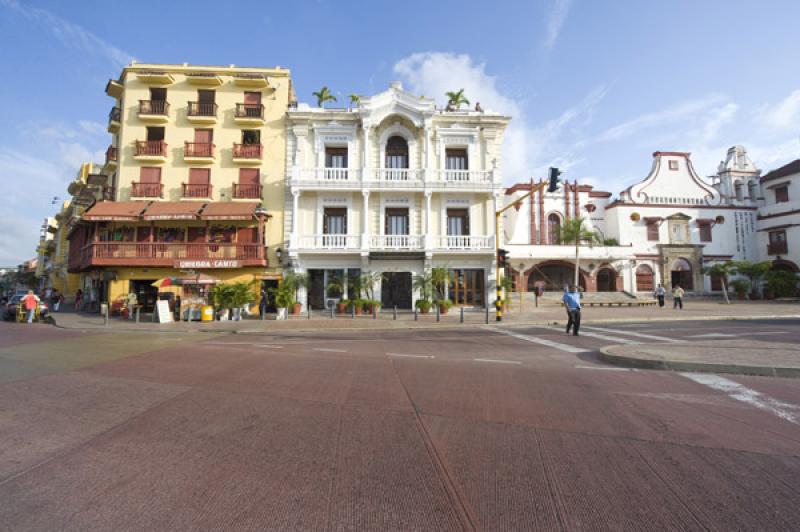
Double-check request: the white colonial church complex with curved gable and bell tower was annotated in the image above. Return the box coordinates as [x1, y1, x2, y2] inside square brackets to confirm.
[504, 146, 780, 293]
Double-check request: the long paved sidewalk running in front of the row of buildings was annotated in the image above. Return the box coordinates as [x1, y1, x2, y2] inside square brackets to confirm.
[45, 299, 800, 332]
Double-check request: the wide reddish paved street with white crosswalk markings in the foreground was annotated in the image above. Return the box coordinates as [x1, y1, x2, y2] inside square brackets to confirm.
[0, 319, 800, 530]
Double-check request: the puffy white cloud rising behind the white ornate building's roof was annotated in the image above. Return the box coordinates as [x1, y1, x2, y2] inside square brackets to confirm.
[394, 52, 607, 183]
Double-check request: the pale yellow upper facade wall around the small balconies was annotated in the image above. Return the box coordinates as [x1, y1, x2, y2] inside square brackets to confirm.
[105, 64, 290, 271]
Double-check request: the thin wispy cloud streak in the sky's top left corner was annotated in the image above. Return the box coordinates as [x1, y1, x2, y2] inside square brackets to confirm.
[0, 0, 133, 68]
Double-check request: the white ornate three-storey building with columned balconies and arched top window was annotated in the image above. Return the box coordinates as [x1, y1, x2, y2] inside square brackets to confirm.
[285, 82, 509, 308]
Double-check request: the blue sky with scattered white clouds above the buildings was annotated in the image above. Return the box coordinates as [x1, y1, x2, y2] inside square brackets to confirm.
[0, 0, 800, 266]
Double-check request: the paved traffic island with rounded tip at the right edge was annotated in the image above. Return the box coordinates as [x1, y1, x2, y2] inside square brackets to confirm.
[600, 339, 800, 378]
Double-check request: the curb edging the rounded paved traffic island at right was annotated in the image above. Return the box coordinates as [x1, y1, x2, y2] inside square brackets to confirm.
[598, 345, 800, 379]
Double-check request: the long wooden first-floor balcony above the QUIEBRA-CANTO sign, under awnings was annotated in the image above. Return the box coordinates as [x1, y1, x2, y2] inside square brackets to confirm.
[80, 242, 267, 269]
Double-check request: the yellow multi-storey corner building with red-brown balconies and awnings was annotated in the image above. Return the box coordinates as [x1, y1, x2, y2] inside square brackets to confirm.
[70, 63, 294, 314]
